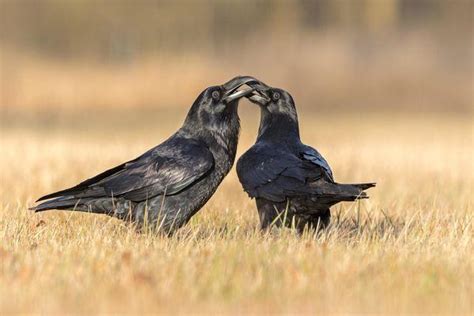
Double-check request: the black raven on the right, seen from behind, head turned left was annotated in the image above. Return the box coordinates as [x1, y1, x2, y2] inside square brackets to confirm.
[237, 82, 375, 231]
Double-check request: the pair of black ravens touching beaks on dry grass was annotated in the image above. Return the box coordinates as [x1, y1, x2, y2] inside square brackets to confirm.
[32, 76, 375, 233]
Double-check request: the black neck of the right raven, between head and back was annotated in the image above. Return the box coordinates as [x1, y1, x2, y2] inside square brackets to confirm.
[257, 111, 300, 141]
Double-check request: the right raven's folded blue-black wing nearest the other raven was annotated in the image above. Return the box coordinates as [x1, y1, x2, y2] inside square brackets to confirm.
[237, 145, 322, 202]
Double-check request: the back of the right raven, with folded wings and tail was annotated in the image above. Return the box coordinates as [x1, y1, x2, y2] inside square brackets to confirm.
[237, 141, 373, 208]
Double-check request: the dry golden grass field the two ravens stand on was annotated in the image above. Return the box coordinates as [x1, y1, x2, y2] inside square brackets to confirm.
[0, 108, 474, 314]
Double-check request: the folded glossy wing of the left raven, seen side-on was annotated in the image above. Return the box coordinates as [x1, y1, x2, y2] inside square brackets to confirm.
[38, 138, 214, 201]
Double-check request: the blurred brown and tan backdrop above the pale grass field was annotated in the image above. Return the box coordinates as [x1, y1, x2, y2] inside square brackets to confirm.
[0, 0, 473, 126]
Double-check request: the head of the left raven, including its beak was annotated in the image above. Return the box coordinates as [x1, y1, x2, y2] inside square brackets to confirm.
[186, 76, 257, 129]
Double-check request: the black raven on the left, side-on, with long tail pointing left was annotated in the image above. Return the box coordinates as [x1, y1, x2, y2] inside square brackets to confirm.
[32, 77, 255, 233]
